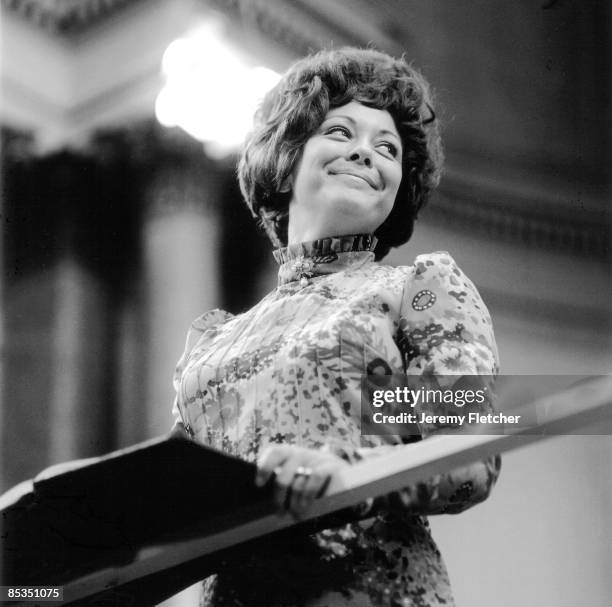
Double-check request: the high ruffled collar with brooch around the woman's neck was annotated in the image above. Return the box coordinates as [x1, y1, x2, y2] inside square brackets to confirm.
[273, 234, 377, 286]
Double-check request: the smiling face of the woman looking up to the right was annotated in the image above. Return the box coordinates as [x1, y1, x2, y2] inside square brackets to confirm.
[289, 101, 402, 242]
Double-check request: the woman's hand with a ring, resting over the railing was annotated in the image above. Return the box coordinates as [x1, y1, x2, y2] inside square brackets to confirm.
[255, 445, 349, 520]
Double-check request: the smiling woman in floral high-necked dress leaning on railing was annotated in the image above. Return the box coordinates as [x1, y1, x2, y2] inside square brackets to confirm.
[175, 48, 500, 606]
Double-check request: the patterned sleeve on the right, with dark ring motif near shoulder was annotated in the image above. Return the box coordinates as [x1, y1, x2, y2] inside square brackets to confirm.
[346, 252, 501, 515]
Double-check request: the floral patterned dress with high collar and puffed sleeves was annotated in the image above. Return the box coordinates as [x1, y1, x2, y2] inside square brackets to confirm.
[174, 235, 500, 607]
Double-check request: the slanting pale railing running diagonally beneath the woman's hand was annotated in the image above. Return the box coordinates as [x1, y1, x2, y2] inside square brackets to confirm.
[4, 376, 612, 605]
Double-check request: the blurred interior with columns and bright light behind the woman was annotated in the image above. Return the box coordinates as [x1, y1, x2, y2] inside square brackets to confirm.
[0, 0, 612, 607]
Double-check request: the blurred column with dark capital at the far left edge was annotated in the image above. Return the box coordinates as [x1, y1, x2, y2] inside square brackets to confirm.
[2, 144, 119, 488]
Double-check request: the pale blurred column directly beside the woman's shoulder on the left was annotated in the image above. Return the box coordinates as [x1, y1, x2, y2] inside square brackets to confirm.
[143, 142, 221, 437]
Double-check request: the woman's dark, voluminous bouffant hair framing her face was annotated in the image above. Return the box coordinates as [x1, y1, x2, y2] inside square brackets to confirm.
[238, 47, 443, 259]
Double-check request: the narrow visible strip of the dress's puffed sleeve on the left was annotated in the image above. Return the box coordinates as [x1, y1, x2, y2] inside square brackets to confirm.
[171, 309, 234, 437]
